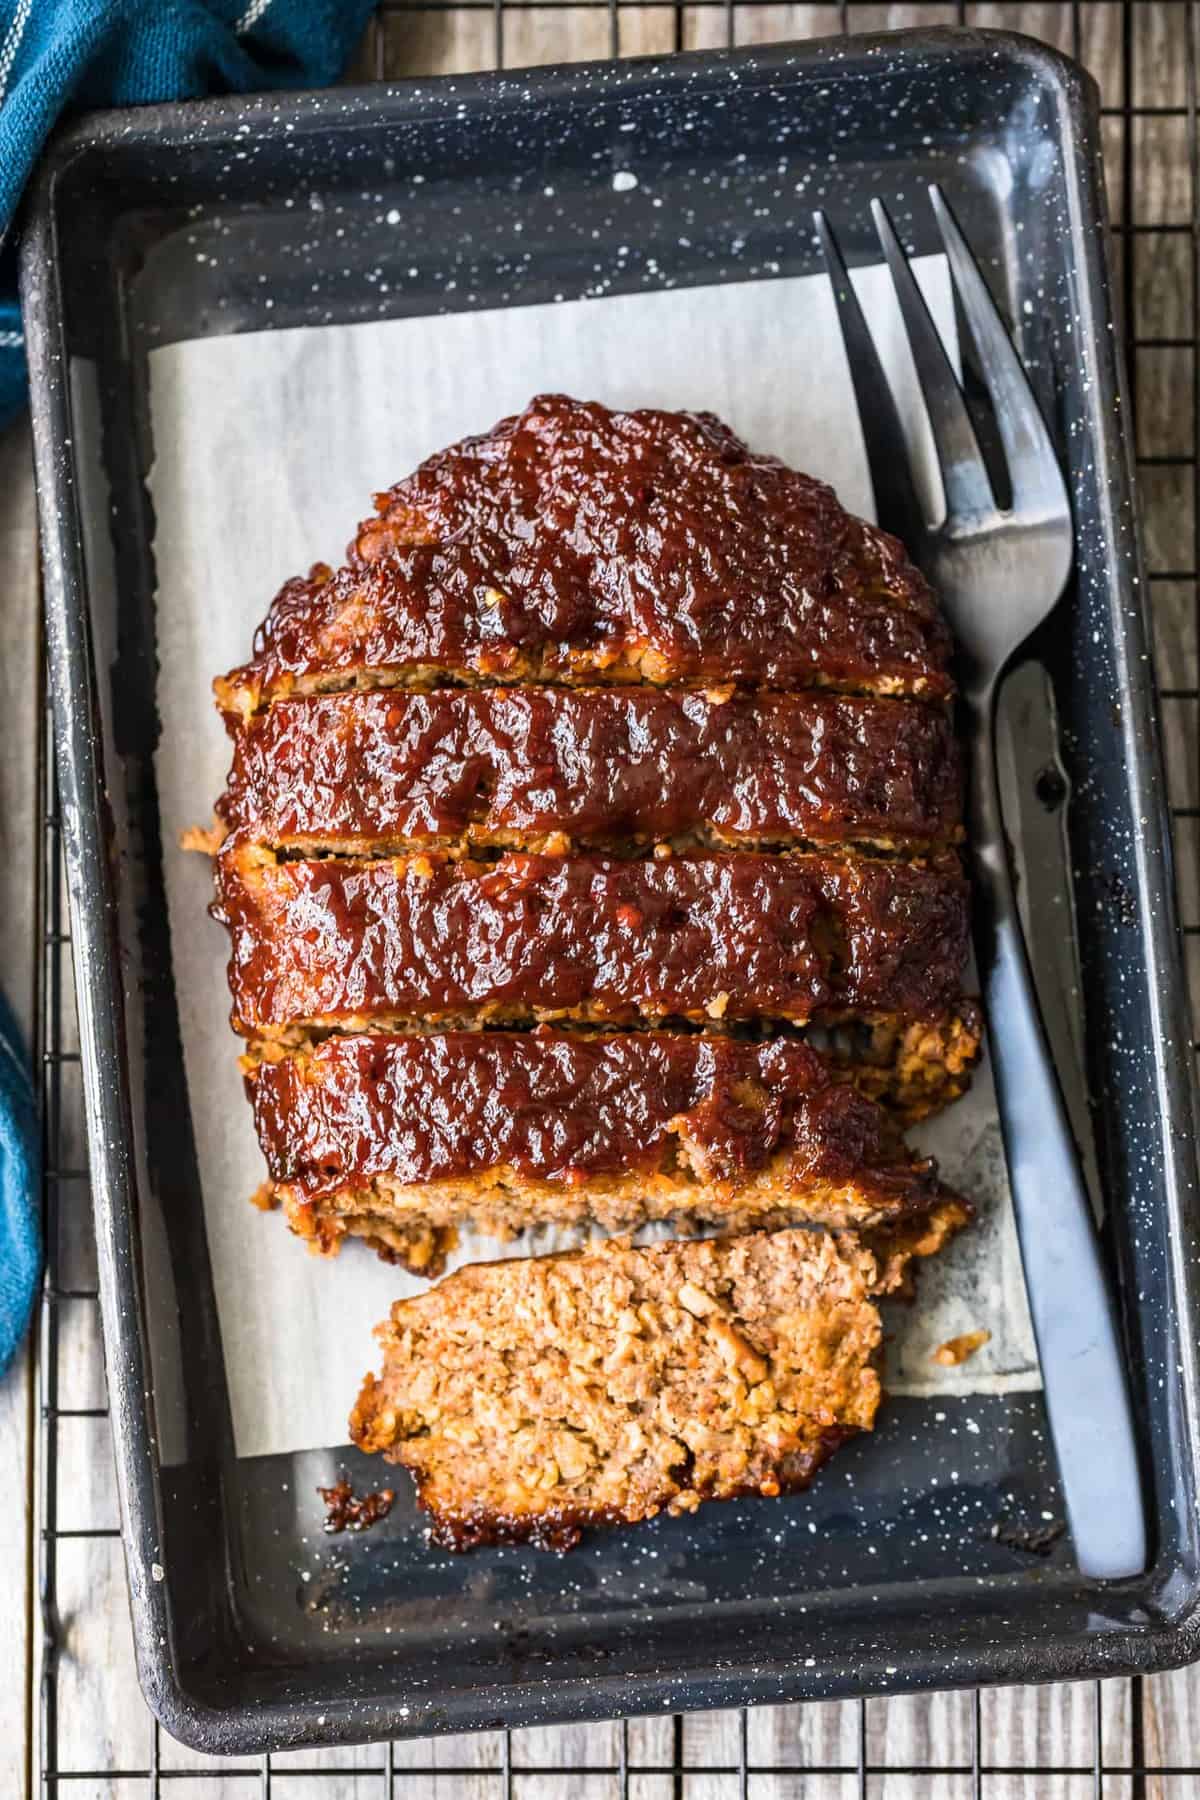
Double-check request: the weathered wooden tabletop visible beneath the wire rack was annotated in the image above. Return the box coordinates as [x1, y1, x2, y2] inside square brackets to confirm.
[9, 0, 1200, 1800]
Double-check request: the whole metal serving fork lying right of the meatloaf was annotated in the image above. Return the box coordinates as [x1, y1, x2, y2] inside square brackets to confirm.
[815, 187, 1146, 1579]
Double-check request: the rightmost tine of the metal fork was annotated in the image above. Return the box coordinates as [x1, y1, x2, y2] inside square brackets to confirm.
[928, 182, 1067, 509]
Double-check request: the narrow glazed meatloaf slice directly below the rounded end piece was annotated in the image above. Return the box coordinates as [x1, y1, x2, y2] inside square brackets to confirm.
[218, 688, 963, 855]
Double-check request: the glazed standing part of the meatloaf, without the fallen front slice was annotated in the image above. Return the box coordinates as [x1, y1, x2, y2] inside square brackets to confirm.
[212, 396, 979, 1303]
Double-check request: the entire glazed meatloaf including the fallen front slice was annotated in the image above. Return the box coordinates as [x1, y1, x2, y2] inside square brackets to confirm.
[204, 396, 981, 1546]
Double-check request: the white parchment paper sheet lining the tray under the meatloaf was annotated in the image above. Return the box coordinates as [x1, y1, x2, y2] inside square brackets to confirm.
[149, 257, 1040, 1456]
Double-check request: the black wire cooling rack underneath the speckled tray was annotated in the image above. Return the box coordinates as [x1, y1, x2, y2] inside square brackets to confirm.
[34, 0, 1200, 1800]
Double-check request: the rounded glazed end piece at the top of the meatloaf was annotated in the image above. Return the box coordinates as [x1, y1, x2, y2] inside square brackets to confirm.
[216, 396, 950, 718]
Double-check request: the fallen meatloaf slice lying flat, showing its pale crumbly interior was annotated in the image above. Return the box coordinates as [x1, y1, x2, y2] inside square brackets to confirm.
[349, 1231, 942, 1550]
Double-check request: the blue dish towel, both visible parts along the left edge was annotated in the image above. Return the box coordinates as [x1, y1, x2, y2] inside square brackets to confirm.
[0, 0, 372, 1372]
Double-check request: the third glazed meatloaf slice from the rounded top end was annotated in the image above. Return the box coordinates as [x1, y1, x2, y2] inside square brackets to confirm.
[212, 844, 970, 1042]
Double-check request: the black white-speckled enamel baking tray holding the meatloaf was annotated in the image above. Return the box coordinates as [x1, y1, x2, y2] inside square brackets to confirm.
[22, 17, 1200, 1753]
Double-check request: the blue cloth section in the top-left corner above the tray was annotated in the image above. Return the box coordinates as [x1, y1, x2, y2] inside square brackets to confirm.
[0, 0, 374, 428]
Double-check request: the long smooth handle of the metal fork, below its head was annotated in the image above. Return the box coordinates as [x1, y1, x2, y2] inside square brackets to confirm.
[968, 689, 1146, 1580]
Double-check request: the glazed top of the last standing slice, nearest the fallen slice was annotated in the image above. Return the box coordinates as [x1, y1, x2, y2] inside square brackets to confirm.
[248, 1028, 939, 1208]
